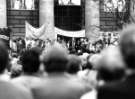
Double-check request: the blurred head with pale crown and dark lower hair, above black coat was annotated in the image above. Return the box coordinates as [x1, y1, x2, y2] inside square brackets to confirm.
[97, 46, 125, 81]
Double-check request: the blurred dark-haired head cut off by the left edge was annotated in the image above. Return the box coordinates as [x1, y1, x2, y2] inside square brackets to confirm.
[0, 41, 9, 73]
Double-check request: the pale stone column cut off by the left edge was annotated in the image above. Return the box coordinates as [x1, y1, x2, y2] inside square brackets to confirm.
[0, 0, 7, 28]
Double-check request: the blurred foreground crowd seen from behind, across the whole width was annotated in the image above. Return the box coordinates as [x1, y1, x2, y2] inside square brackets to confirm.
[0, 24, 135, 99]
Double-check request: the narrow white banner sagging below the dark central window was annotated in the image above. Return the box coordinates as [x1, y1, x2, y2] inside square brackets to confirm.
[55, 27, 85, 37]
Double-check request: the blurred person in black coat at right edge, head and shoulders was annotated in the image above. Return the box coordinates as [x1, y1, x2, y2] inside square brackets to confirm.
[98, 24, 135, 99]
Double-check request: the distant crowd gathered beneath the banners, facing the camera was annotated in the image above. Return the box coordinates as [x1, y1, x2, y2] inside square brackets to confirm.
[9, 32, 119, 58]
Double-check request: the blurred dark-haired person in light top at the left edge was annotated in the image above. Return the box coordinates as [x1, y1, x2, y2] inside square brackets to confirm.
[0, 41, 32, 99]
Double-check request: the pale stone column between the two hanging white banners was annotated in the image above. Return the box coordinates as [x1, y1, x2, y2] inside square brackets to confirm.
[39, 0, 56, 40]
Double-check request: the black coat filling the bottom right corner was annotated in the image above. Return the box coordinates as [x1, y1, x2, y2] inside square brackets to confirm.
[98, 75, 135, 99]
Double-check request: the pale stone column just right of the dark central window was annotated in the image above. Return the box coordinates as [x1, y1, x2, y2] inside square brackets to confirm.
[85, 0, 100, 42]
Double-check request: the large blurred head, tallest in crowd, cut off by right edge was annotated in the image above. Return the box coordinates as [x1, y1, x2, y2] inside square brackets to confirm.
[120, 24, 135, 69]
